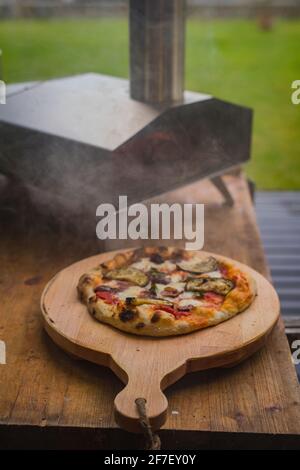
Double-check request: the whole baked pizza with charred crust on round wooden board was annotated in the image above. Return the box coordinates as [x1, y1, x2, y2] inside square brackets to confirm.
[77, 247, 256, 336]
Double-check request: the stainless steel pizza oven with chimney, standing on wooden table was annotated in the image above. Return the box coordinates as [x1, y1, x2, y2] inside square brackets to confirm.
[0, 0, 252, 241]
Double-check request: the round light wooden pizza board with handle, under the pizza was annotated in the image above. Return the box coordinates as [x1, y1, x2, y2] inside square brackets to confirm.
[41, 250, 280, 432]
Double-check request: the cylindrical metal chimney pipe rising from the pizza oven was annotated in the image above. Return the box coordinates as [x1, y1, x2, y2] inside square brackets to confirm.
[129, 0, 185, 104]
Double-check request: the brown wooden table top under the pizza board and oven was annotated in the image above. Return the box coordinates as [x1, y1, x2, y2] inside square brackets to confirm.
[0, 175, 300, 449]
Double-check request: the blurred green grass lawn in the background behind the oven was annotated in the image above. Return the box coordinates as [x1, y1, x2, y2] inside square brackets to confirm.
[0, 19, 300, 189]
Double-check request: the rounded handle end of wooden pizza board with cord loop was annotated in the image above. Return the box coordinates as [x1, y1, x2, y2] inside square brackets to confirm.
[115, 375, 168, 433]
